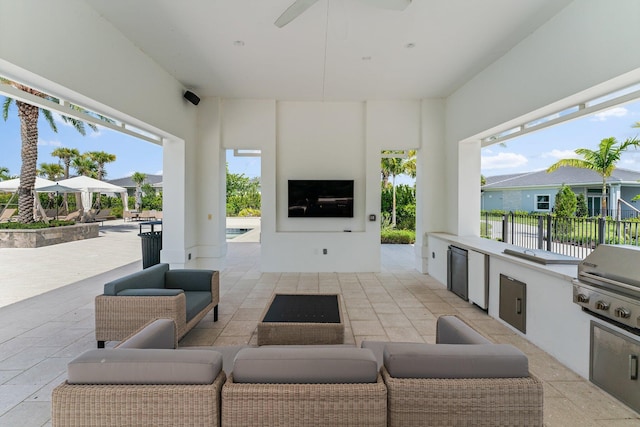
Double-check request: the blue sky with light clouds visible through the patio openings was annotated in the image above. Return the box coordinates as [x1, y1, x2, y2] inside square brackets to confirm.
[0, 98, 640, 183]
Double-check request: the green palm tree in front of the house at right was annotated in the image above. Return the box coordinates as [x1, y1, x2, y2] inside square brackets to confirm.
[547, 137, 640, 215]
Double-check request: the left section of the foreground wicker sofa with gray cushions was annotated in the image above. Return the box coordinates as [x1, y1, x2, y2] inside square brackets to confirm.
[51, 319, 226, 427]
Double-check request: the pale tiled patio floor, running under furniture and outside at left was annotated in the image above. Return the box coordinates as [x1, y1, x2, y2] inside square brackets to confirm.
[0, 221, 640, 426]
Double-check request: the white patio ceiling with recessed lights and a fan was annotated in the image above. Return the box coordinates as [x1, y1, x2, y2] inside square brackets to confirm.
[84, 0, 570, 101]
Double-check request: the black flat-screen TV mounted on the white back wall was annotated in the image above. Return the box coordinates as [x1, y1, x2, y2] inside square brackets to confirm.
[289, 179, 353, 218]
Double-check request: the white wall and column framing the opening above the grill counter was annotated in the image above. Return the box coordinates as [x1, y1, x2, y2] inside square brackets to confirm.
[445, 0, 640, 235]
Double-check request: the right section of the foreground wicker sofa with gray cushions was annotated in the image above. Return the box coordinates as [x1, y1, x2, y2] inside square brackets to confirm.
[362, 316, 543, 427]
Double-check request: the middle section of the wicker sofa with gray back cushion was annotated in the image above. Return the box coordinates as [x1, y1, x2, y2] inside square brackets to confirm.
[222, 346, 387, 427]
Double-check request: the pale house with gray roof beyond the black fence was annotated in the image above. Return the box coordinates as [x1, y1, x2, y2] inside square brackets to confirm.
[481, 167, 640, 218]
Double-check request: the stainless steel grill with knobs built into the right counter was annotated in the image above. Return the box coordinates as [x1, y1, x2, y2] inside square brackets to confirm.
[573, 245, 640, 335]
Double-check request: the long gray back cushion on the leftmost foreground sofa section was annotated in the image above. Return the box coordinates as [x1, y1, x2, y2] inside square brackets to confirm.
[67, 348, 222, 384]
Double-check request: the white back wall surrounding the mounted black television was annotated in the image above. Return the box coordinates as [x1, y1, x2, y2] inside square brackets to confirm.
[208, 99, 424, 271]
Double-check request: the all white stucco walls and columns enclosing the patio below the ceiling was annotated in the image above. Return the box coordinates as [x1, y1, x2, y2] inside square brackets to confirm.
[0, 0, 640, 271]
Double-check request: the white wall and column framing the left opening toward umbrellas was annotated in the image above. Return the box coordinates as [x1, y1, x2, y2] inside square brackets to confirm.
[0, 0, 196, 266]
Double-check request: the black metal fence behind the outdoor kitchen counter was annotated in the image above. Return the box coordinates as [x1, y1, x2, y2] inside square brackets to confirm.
[480, 212, 640, 258]
